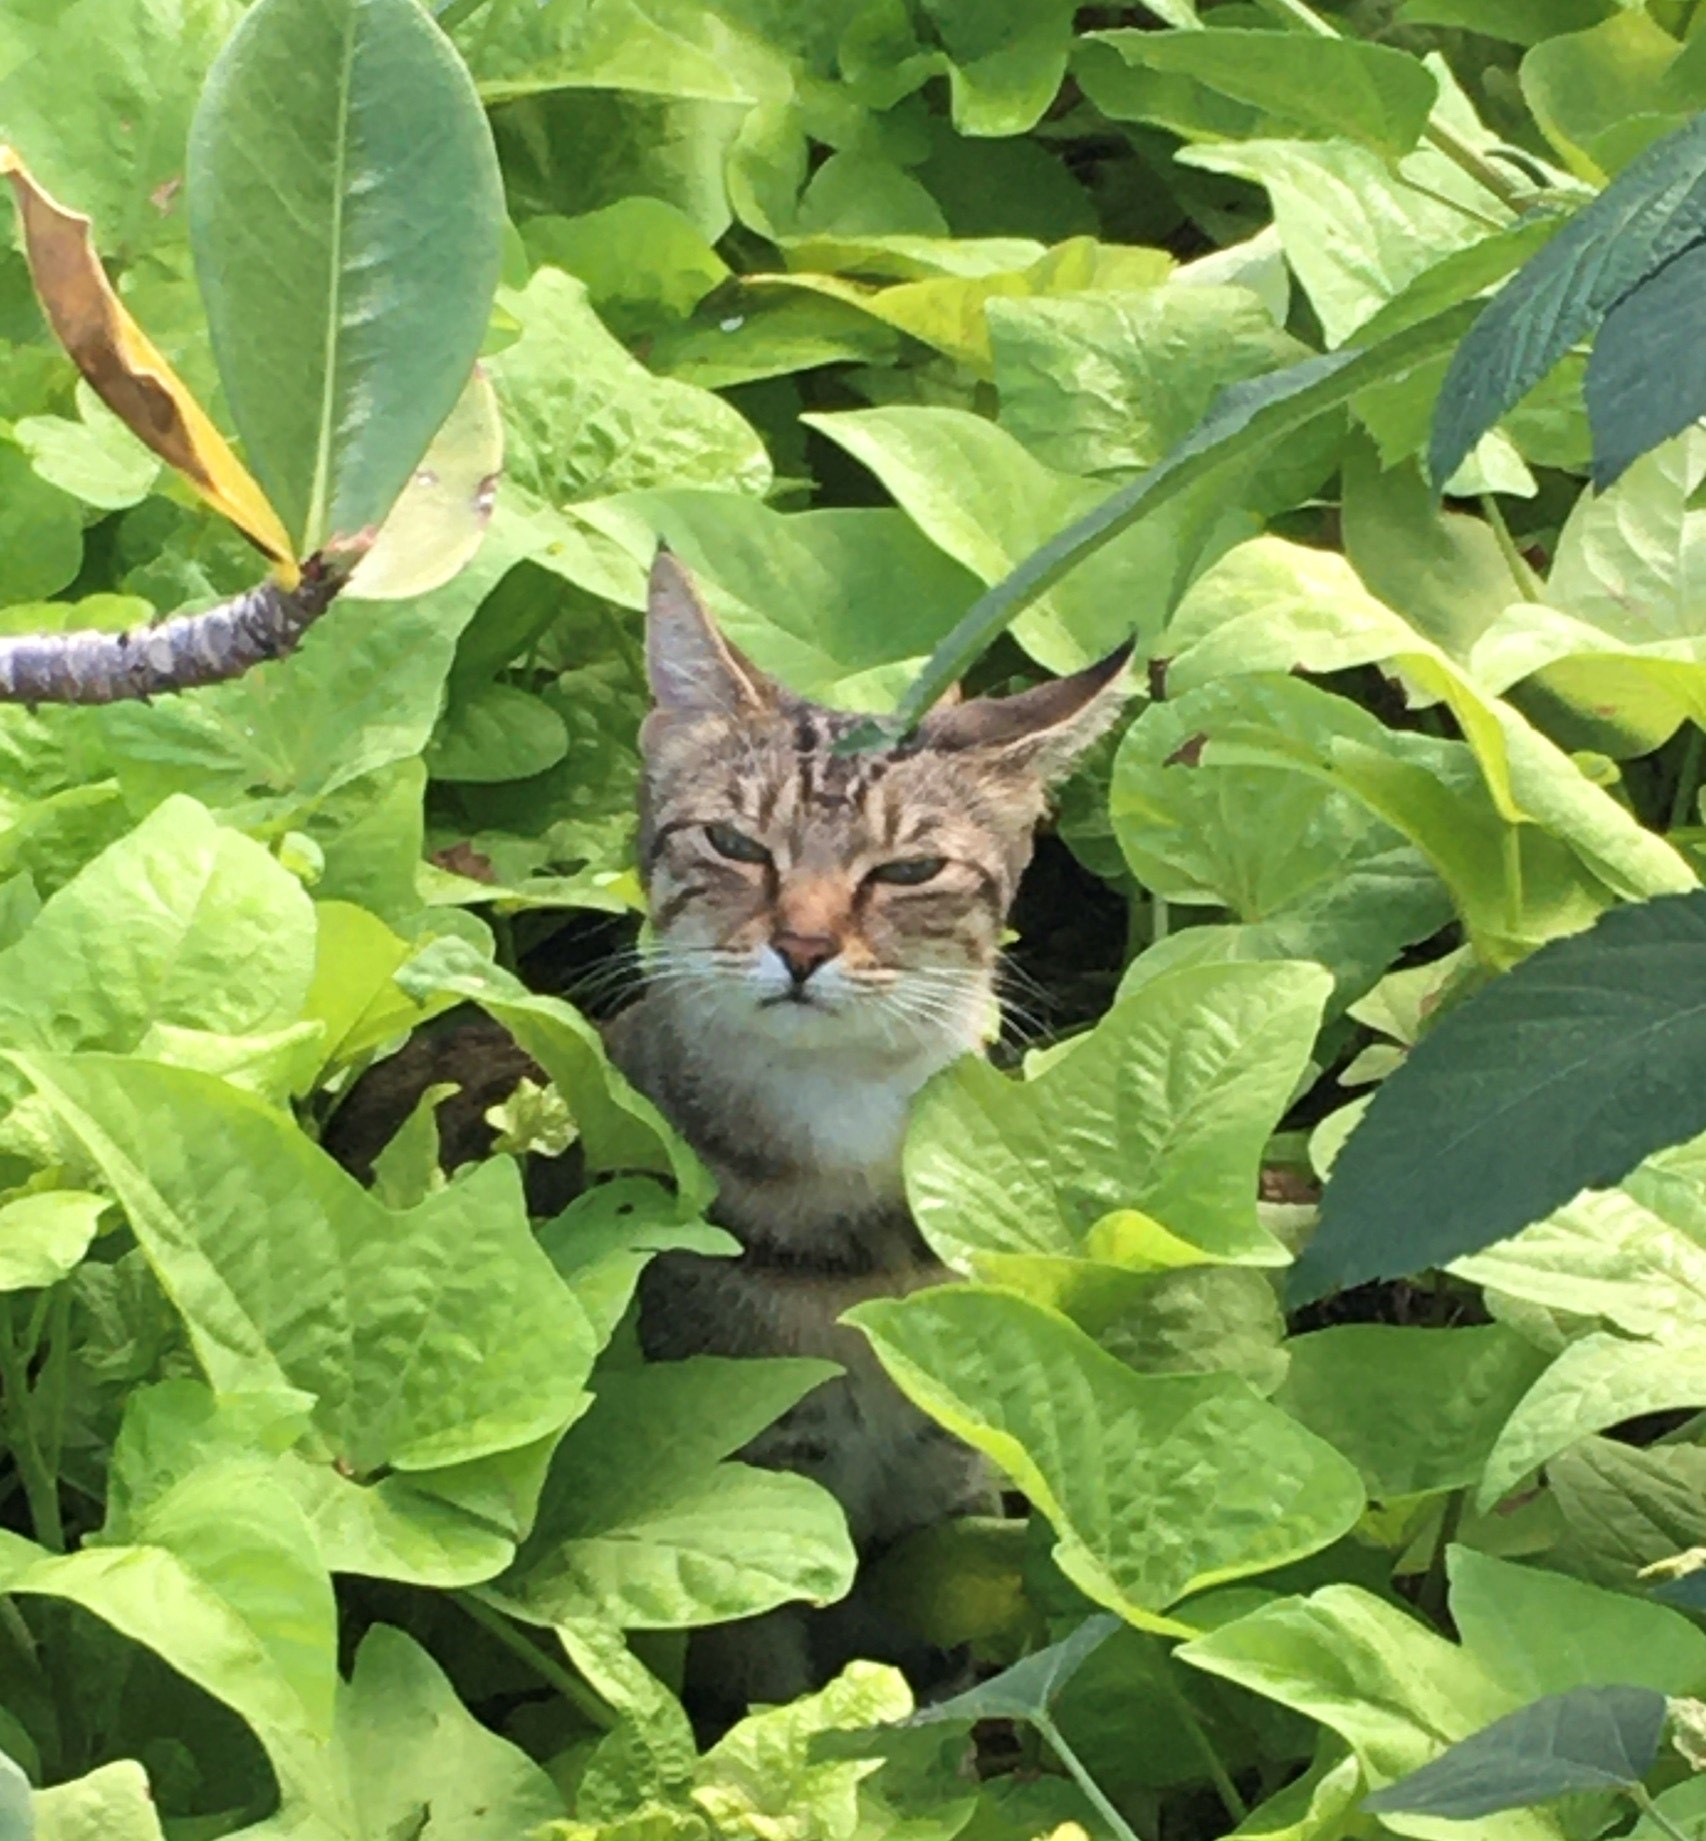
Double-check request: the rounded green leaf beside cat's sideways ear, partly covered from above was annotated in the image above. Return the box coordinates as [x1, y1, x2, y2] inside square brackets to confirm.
[1108, 692, 1450, 1003]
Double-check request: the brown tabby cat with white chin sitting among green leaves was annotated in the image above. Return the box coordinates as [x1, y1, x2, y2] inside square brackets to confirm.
[607, 549, 1130, 1716]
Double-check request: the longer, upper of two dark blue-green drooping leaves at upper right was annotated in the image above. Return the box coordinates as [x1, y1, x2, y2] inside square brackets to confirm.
[1428, 116, 1706, 482]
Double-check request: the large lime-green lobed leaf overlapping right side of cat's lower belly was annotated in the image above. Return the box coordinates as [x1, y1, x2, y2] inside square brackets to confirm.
[848, 1285, 1364, 1633]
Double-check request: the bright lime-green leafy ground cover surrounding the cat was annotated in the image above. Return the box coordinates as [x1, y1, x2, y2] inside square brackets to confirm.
[10, 0, 1706, 1841]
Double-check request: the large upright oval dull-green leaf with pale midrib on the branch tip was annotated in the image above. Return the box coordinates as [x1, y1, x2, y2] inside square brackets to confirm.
[188, 0, 502, 556]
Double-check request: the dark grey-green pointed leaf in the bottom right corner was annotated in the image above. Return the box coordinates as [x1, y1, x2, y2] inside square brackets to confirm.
[1362, 1686, 1667, 1821]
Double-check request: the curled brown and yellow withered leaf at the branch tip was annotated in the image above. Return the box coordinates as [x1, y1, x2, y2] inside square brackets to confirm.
[0, 145, 298, 587]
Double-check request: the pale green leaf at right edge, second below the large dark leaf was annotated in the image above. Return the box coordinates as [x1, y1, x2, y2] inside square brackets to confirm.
[1480, 1335, 1706, 1506]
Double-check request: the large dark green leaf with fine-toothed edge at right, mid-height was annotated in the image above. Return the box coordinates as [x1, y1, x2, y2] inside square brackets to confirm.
[1296, 895, 1706, 1296]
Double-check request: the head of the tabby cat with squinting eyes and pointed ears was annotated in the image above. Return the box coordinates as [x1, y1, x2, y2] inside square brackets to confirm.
[640, 550, 1130, 1064]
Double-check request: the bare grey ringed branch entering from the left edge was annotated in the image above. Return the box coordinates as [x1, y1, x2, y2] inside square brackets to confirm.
[0, 556, 348, 705]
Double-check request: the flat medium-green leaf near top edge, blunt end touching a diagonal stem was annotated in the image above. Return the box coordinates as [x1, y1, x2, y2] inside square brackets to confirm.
[1088, 26, 1437, 156]
